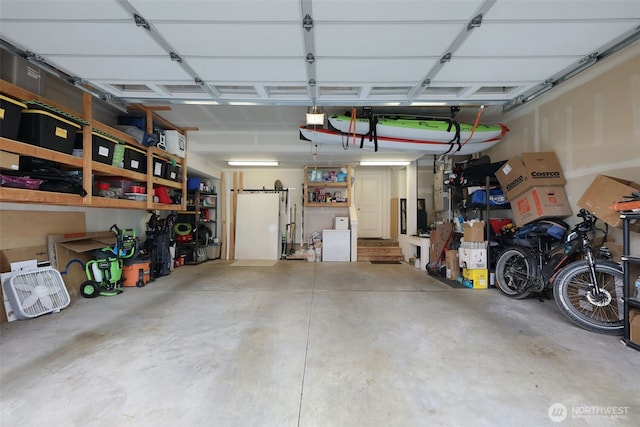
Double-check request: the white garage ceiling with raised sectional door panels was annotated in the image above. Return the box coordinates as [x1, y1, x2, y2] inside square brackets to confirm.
[0, 0, 640, 167]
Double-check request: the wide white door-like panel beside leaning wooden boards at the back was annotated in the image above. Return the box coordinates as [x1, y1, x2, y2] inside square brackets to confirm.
[235, 193, 280, 260]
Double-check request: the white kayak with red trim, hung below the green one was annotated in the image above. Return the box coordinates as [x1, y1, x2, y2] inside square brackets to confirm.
[300, 126, 507, 155]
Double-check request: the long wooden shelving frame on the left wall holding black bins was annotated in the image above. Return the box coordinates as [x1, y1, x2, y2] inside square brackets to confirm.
[0, 80, 187, 210]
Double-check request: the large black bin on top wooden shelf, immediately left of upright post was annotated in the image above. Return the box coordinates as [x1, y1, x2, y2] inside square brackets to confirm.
[18, 110, 80, 154]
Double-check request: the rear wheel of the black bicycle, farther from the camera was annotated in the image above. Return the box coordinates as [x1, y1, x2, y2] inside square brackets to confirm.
[496, 247, 537, 299]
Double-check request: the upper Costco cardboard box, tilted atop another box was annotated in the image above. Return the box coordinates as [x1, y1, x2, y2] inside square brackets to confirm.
[495, 152, 566, 201]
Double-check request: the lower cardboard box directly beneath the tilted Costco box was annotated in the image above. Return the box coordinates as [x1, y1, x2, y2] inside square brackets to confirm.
[511, 186, 572, 227]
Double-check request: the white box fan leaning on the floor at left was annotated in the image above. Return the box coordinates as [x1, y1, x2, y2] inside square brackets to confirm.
[3, 267, 71, 320]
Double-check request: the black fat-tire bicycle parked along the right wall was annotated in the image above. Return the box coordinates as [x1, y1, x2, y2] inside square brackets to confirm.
[496, 209, 624, 335]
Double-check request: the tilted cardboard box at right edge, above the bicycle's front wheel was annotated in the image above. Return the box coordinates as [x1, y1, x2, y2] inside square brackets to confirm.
[577, 175, 640, 233]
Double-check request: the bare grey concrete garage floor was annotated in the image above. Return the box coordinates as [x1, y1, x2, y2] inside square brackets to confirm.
[0, 260, 640, 427]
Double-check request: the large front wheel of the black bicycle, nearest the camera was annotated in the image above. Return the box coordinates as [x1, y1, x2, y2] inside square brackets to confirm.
[553, 260, 624, 335]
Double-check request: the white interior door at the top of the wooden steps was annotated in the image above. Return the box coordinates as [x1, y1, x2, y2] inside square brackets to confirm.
[354, 170, 386, 238]
